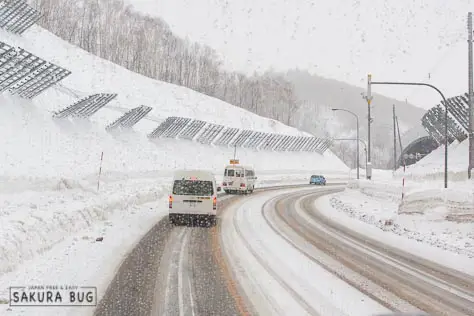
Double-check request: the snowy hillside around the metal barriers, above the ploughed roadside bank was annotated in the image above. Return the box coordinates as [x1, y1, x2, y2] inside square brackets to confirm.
[0, 27, 345, 186]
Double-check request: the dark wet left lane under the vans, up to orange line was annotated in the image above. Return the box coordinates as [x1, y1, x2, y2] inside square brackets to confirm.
[94, 185, 326, 316]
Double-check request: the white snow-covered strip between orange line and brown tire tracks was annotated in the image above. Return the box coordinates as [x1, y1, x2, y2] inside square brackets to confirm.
[220, 186, 370, 316]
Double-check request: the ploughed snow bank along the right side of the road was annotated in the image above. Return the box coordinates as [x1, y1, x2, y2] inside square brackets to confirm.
[328, 181, 474, 258]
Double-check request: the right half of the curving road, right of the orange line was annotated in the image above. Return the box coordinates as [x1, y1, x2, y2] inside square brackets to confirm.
[221, 188, 474, 316]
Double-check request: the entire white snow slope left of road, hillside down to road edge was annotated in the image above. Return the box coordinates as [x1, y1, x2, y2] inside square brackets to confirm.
[0, 22, 347, 315]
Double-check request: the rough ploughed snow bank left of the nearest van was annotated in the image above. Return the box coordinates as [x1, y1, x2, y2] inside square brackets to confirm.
[0, 181, 168, 276]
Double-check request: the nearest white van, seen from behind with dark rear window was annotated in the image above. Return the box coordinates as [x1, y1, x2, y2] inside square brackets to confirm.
[168, 170, 221, 226]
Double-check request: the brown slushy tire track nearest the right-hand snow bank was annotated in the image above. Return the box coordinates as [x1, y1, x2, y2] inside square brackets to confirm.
[270, 189, 474, 315]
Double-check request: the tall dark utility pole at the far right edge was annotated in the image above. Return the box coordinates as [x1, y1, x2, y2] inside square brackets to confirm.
[467, 12, 474, 179]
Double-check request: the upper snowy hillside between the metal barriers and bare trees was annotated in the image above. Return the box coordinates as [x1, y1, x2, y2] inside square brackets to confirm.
[0, 26, 310, 135]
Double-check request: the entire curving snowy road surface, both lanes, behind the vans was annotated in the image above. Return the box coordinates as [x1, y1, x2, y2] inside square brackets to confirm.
[91, 184, 474, 316]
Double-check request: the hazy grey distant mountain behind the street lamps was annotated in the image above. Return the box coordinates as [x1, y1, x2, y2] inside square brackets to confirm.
[285, 70, 426, 168]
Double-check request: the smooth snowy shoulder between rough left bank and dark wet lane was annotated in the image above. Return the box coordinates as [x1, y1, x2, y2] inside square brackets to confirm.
[0, 198, 167, 316]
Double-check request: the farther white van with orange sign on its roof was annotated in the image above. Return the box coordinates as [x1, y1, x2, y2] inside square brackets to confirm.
[222, 164, 257, 193]
